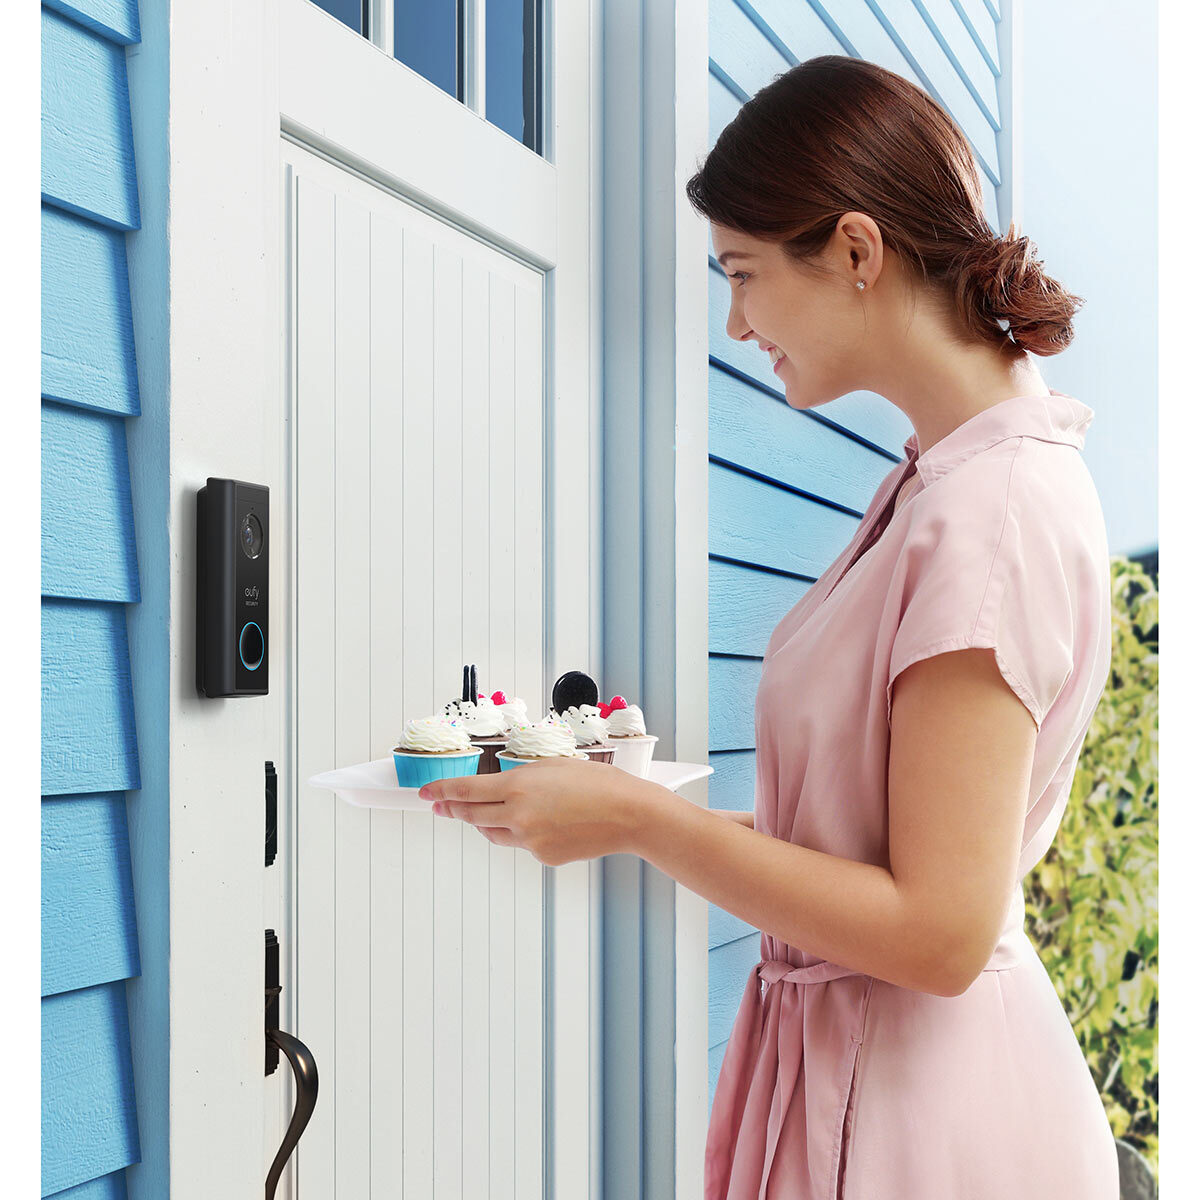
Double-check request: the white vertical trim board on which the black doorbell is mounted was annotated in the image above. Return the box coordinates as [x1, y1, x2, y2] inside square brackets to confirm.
[164, 0, 280, 1185]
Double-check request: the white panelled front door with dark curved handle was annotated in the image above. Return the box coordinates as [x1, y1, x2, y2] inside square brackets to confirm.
[264, 0, 599, 1200]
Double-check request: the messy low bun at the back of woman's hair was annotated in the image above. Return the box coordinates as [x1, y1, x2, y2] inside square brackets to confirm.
[959, 223, 1084, 355]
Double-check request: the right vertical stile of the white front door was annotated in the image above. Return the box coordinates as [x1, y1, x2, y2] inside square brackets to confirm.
[542, 0, 604, 1200]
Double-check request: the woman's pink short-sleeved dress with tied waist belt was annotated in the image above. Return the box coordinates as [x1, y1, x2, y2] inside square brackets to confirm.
[704, 391, 1118, 1200]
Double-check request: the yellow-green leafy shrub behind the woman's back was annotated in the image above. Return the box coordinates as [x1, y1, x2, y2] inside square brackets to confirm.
[1026, 557, 1158, 1177]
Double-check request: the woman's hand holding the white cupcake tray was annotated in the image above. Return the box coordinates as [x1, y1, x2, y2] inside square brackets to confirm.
[420, 758, 661, 866]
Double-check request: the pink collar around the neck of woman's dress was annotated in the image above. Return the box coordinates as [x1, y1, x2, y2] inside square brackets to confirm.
[904, 388, 1096, 486]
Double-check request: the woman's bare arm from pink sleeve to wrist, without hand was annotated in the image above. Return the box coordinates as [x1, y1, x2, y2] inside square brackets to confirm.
[628, 649, 1037, 996]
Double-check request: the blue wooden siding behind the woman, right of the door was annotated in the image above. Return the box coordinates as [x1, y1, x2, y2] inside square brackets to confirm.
[708, 0, 1001, 1104]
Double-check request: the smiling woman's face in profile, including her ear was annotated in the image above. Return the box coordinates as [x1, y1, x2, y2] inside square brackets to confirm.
[712, 214, 882, 408]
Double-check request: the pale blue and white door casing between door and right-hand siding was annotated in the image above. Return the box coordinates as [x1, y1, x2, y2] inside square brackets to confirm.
[601, 0, 708, 1196]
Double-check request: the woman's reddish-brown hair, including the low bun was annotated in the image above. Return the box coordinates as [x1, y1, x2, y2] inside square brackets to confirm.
[686, 54, 1084, 355]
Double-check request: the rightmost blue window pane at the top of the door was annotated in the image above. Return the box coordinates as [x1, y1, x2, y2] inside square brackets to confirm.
[484, 0, 542, 154]
